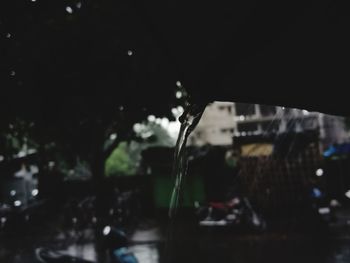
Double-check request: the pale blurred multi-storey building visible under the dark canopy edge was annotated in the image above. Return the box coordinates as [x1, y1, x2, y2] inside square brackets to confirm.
[189, 102, 348, 147]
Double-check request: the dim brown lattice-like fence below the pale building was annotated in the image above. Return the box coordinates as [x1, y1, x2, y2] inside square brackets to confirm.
[239, 144, 323, 218]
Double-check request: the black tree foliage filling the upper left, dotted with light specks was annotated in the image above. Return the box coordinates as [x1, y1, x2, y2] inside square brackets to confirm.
[0, 0, 185, 179]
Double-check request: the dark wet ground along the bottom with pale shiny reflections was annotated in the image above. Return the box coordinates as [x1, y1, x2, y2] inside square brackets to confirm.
[0, 217, 350, 263]
